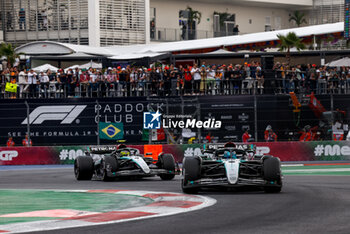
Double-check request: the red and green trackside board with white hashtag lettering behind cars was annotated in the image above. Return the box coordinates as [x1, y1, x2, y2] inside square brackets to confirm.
[0, 141, 350, 165]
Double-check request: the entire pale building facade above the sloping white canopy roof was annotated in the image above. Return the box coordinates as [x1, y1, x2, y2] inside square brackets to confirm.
[0, 0, 344, 46]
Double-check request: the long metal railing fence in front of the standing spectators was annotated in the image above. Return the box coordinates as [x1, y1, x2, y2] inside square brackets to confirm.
[0, 78, 350, 99]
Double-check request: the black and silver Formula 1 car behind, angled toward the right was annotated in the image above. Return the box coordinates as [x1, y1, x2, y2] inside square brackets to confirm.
[74, 145, 179, 181]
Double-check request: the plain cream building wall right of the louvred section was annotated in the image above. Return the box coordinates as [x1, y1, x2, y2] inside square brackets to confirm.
[150, 0, 312, 41]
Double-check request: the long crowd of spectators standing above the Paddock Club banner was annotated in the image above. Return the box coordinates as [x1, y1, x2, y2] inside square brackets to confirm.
[0, 61, 350, 98]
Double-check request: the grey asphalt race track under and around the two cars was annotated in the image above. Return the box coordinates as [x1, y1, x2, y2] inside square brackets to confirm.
[0, 168, 350, 234]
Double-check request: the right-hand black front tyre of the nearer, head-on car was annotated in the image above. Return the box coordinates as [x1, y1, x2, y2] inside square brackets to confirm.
[263, 157, 282, 193]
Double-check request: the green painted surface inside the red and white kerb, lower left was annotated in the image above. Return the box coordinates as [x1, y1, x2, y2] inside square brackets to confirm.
[0, 190, 153, 225]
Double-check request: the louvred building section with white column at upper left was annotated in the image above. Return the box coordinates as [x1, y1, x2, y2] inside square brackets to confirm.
[1, 0, 149, 46]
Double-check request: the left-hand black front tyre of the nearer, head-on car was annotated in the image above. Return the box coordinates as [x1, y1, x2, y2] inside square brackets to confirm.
[181, 157, 201, 194]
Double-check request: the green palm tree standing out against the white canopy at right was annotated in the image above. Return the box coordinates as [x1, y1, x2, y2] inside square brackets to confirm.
[277, 32, 306, 66]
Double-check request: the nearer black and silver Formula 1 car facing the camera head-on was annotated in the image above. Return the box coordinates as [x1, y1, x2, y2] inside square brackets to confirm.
[182, 143, 282, 193]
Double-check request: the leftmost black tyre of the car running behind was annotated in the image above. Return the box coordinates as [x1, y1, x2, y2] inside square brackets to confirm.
[74, 156, 94, 180]
